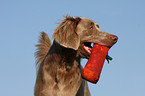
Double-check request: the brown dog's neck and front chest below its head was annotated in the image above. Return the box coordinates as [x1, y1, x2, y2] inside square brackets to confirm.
[37, 41, 82, 96]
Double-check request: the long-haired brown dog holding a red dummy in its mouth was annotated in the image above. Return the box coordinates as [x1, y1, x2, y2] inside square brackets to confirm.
[35, 16, 118, 96]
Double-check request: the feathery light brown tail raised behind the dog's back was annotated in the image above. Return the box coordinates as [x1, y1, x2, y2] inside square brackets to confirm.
[35, 32, 51, 66]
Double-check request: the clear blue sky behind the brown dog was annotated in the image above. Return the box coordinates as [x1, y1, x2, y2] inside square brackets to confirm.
[0, 0, 145, 96]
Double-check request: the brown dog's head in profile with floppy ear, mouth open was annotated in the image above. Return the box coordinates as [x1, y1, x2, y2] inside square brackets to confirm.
[53, 16, 118, 58]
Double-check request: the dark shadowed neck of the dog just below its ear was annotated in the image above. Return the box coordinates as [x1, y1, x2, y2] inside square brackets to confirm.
[48, 40, 80, 70]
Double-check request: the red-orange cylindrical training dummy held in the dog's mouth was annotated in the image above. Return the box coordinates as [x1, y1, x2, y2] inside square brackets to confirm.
[82, 44, 109, 83]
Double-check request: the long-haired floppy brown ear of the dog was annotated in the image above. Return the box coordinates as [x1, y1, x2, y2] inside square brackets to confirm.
[53, 16, 81, 50]
